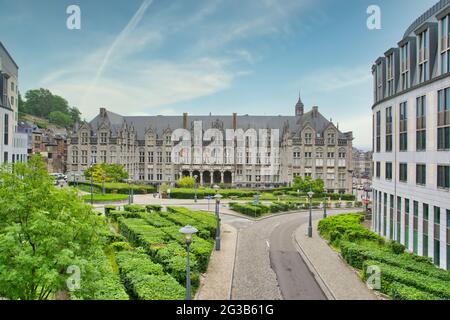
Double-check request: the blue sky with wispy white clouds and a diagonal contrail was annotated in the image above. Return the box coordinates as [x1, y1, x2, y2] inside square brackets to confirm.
[0, 0, 437, 149]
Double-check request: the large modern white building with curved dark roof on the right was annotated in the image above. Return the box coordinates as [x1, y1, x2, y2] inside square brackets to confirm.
[372, 0, 450, 269]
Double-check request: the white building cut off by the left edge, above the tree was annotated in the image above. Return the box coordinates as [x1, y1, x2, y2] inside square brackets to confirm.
[0, 42, 28, 164]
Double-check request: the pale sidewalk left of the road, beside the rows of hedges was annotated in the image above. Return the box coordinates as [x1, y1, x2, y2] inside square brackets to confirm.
[195, 224, 237, 300]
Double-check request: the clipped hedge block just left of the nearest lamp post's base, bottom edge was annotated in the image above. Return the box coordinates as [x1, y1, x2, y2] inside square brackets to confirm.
[116, 251, 185, 300]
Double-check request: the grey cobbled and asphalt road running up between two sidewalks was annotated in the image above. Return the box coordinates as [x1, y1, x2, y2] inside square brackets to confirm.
[222, 209, 362, 300]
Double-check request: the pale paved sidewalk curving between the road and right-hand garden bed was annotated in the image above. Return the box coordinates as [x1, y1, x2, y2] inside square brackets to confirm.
[294, 221, 379, 300]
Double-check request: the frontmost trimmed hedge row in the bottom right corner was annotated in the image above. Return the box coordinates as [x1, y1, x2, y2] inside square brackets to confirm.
[362, 260, 450, 299]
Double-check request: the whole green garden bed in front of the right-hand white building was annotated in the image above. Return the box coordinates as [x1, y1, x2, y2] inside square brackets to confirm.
[318, 214, 450, 300]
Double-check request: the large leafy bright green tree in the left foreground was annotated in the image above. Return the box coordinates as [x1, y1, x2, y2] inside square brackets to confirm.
[0, 156, 106, 300]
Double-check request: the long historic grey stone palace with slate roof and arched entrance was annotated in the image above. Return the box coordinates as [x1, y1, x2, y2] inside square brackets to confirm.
[67, 95, 353, 193]
